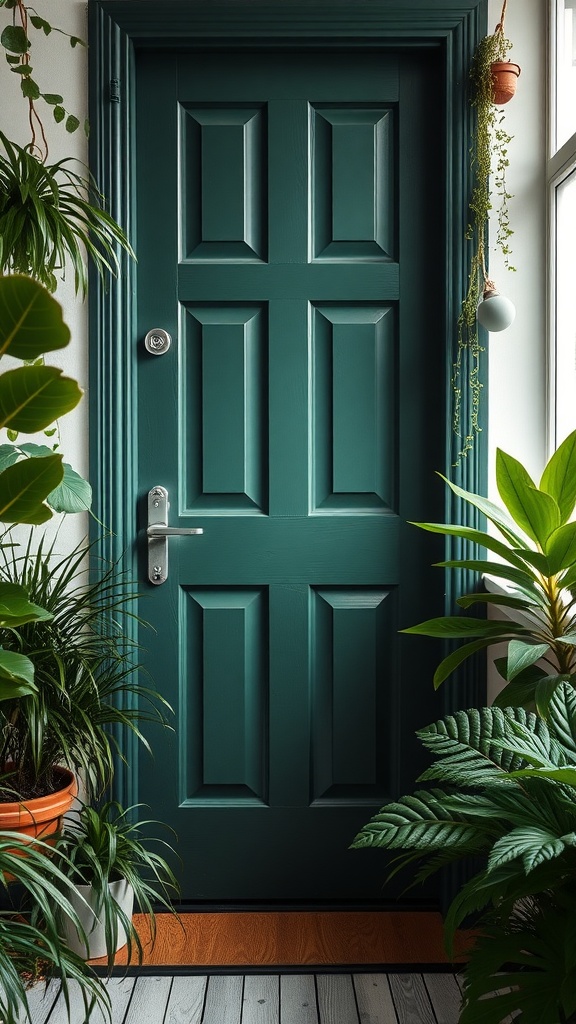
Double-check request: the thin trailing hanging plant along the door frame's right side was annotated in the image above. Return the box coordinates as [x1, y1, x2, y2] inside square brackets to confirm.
[452, 0, 520, 465]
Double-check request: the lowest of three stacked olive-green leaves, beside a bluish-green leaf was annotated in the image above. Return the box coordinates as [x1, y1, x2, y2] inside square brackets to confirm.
[0, 455, 64, 525]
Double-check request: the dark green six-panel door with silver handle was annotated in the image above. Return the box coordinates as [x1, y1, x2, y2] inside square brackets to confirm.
[135, 48, 446, 900]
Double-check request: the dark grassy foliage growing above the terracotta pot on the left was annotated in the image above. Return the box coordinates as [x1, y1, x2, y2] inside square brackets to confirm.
[0, 532, 169, 800]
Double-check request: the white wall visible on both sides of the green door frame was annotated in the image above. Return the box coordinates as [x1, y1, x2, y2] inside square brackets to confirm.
[0, 0, 547, 539]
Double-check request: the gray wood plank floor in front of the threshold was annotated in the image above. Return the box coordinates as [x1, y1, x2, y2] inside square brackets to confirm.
[17, 973, 460, 1024]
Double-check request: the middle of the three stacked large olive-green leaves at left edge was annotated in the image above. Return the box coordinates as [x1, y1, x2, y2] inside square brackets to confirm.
[0, 366, 82, 434]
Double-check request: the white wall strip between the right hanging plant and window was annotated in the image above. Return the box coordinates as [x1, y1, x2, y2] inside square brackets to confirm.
[488, 0, 547, 477]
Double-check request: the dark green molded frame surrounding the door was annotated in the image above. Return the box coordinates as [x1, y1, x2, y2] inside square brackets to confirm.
[88, 0, 488, 806]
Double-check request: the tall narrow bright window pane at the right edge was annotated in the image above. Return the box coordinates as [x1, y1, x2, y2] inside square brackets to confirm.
[548, 0, 576, 447]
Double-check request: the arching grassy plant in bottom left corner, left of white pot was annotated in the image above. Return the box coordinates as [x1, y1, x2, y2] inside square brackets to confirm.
[0, 831, 111, 1024]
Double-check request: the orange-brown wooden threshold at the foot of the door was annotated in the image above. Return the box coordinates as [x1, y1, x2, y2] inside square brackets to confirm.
[87, 910, 465, 967]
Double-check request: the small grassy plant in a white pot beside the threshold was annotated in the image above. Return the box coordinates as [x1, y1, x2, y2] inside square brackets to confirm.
[56, 801, 178, 967]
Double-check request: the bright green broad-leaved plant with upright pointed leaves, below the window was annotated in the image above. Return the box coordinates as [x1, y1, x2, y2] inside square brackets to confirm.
[403, 431, 576, 716]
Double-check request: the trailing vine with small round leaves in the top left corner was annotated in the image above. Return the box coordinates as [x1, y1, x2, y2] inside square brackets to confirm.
[0, 0, 88, 162]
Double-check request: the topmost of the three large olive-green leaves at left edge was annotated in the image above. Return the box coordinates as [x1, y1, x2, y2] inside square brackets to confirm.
[0, 273, 70, 359]
